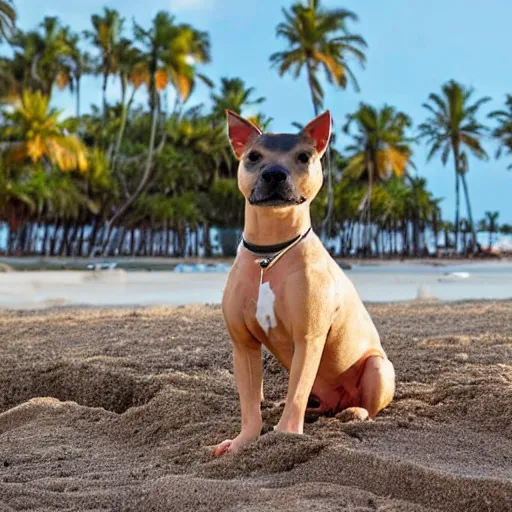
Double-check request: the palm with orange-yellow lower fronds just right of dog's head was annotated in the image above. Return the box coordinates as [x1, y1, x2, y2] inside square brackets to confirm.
[344, 104, 412, 253]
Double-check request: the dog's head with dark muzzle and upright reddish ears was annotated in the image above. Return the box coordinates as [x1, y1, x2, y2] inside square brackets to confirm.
[226, 111, 331, 208]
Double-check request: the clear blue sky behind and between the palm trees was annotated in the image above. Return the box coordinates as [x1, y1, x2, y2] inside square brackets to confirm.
[7, 0, 512, 223]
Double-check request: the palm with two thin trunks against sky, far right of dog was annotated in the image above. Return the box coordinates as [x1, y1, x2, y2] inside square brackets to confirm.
[419, 80, 490, 250]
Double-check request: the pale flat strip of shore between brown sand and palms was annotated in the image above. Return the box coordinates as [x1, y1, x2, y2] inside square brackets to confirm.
[0, 258, 512, 309]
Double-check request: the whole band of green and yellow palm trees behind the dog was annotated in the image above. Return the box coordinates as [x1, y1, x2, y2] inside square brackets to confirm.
[0, 0, 512, 256]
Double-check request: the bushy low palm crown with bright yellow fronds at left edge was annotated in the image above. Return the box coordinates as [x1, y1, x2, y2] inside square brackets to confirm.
[3, 90, 88, 171]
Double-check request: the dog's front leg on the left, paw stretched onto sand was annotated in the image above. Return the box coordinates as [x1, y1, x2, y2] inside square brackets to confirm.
[215, 341, 263, 456]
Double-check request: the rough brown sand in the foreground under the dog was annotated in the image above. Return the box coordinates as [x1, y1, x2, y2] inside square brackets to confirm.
[0, 301, 512, 512]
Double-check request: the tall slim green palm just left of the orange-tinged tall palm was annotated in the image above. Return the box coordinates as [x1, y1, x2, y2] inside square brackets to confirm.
[85, 7, 124, 117]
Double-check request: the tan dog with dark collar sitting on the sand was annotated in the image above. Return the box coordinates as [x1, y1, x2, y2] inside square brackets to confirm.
[215, 111, 395, 455]
